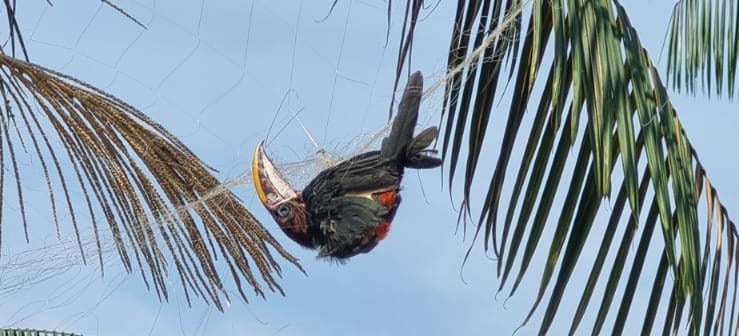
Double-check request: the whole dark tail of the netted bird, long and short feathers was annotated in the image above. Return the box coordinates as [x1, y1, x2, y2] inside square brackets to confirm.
[381, 71, 442, 169]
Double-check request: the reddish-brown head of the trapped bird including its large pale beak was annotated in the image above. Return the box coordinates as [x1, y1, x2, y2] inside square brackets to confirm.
[252, 141, 315, 248]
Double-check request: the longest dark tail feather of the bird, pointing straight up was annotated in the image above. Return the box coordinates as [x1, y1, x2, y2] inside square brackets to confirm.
[381, 71, 423, 157]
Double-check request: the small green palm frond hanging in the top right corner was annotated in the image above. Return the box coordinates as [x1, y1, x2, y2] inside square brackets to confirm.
[667, 0, 739, 97]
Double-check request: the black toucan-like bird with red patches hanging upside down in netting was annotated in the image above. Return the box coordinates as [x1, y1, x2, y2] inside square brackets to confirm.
[252, 71, 443, 261]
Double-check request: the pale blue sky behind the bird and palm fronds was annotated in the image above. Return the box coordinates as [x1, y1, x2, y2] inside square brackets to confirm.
[0, 0, 739, 335]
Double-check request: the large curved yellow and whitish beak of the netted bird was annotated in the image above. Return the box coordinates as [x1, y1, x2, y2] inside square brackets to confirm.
[251, 141, 298, 211]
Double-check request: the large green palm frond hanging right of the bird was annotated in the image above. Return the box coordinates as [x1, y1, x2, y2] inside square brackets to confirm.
[398, 0, 739, 334]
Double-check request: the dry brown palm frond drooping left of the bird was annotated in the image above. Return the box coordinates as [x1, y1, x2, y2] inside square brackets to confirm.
[0, 54, 300, 309]
